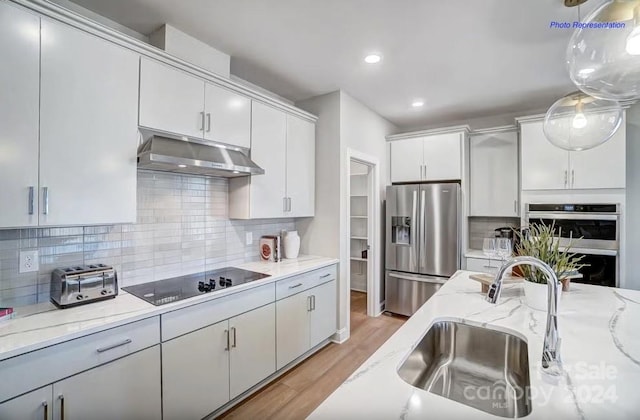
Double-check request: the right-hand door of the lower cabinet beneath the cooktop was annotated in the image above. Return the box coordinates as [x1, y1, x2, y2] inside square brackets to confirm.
[229, 303, 276, 399]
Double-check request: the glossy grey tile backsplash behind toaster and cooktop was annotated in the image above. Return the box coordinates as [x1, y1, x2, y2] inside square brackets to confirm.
[0, 171, 295, 307]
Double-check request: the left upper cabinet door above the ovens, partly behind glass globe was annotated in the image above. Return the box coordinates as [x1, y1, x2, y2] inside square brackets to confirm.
[520, 121, 569, 190]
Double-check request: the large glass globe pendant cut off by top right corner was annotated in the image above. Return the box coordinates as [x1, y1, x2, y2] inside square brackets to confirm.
[567, 0, 640, 101]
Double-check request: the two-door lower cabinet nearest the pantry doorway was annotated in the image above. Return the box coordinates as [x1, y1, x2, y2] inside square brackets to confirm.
[276, 280, 336, 369]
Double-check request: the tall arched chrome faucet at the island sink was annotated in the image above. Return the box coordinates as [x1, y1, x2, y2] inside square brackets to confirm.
[487, 257, 562, 376]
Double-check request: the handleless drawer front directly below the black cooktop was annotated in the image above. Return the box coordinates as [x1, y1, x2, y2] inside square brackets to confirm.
[161, 284, 275, 342]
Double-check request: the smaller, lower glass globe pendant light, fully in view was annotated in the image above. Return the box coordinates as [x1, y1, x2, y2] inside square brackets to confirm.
[543, 91, 622, 151]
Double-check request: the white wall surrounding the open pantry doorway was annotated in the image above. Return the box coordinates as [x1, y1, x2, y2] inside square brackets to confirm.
[296, 91, 396, 340]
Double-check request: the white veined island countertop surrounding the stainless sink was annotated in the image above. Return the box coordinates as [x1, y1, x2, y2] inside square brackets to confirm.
[310, 271, 640, 420]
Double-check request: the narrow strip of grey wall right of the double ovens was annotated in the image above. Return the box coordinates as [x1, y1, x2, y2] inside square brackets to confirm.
[622, 105, 640, 290]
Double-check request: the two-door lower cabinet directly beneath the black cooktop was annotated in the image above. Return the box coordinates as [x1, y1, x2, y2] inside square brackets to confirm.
[162, 303, 276, 420]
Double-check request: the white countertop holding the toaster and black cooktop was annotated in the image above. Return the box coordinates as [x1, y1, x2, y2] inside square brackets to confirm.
[0, 255, 338, 360]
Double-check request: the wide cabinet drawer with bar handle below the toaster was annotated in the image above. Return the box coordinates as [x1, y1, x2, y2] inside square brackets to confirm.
[0, 316, 160, 401]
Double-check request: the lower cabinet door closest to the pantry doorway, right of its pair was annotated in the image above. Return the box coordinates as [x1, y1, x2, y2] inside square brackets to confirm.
[309, 280, 336, 348]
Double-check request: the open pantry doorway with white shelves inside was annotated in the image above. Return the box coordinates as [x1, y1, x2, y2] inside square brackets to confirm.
[342, 149, 382, 325]
